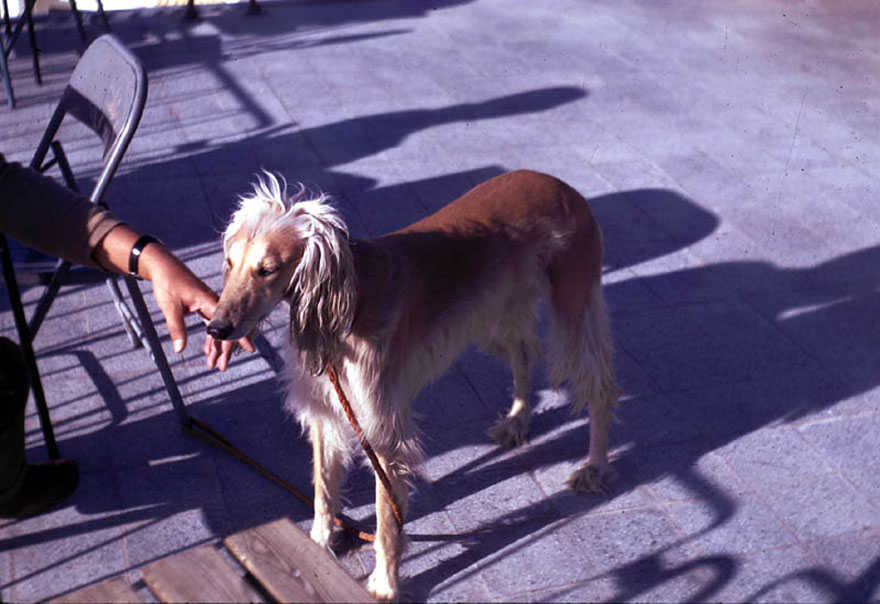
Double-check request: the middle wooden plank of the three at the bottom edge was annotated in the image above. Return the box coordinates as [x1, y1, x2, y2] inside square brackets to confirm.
[141, 545, 265, 602]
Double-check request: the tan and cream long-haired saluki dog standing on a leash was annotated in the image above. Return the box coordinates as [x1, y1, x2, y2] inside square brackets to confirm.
[208, 170, 618, 599]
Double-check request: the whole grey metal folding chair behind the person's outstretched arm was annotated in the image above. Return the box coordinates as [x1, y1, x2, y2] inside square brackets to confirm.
[0, 34, 188, 459]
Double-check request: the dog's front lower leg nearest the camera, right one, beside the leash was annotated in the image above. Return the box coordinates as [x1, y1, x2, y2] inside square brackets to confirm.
[367, 455, 409, 600]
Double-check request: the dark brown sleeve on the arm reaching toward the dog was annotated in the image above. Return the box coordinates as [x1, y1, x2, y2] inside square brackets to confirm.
[0, 154, 122, 267]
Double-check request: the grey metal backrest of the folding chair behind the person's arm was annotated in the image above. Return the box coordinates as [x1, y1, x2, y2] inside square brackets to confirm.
[31, 34, 147, 203]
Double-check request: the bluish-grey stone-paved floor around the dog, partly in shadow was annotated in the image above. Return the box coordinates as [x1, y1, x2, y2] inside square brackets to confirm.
[0, 0, 880, 602]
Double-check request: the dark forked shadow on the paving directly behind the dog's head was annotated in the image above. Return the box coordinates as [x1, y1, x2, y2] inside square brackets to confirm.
[107, 86, 587, 248]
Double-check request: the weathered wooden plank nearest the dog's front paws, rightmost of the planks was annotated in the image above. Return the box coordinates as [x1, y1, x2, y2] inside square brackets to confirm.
[223, 518, 375, 602]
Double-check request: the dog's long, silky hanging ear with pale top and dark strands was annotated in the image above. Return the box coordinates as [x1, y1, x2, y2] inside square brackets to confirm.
[289, 201, 357, 375]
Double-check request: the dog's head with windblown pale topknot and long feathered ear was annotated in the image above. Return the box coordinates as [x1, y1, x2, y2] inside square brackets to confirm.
[208, 173, 356, 374]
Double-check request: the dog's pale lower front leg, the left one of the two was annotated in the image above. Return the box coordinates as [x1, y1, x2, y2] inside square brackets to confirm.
[309, 421, 343, 549]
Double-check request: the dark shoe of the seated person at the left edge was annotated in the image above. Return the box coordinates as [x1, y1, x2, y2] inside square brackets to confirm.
[0, 459, 79, 519]
